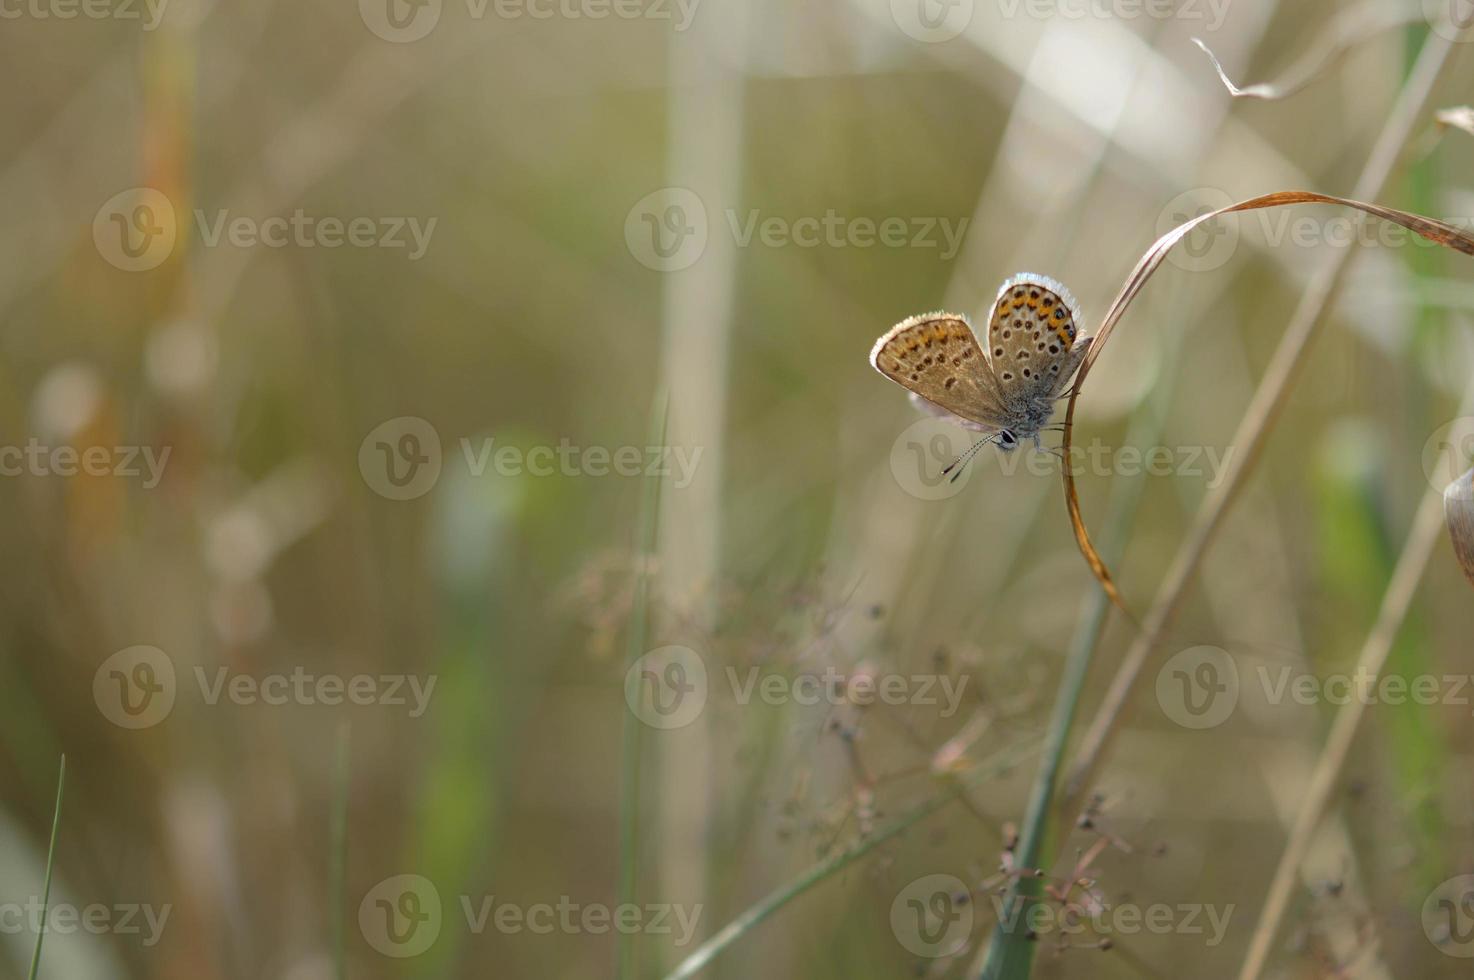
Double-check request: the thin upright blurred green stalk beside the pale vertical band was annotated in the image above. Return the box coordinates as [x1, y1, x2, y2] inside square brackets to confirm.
[615, 391, 669, 980]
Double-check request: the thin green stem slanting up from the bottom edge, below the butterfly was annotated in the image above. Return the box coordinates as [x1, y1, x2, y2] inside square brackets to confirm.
[665, 738, 1039, 980]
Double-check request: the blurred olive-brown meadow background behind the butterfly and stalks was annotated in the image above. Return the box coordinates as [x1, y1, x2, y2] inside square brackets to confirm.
[0, 0, 1474, 980]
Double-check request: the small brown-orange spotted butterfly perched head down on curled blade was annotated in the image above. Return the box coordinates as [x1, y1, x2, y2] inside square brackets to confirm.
[870, 273, 1092, 470]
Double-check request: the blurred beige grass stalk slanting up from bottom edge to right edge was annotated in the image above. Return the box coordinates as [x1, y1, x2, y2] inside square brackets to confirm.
[1238, 374, 1474, 980]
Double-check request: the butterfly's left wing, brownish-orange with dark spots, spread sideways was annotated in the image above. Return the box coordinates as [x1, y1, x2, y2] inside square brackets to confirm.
[870, 312, 1008, 432]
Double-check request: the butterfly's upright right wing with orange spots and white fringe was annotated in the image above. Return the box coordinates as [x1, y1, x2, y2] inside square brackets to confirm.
[988, 273, 1089, 405]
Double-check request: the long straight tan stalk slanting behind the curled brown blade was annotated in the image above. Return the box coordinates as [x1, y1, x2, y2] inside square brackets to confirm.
[1063, 32, 1455, 815]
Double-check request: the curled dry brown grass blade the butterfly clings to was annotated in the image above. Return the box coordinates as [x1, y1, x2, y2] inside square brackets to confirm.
[1061, 190, 1474, 622]
